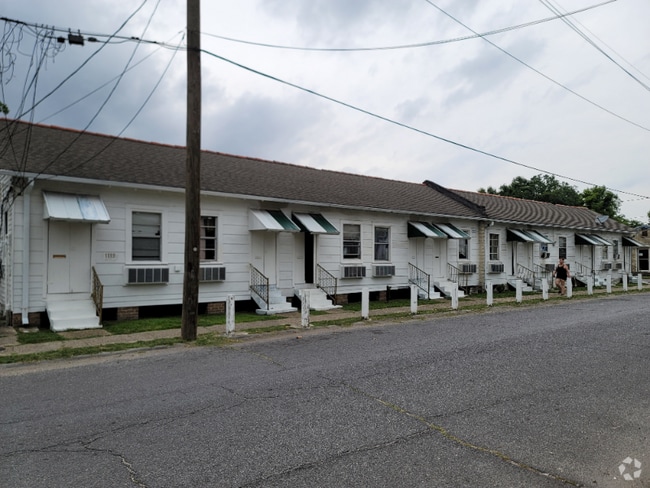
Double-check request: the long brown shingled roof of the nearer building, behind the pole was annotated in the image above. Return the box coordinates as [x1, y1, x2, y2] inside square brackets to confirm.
[0, 122, 481, 219]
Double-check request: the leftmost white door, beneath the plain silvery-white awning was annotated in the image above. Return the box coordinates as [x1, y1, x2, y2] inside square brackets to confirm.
[47, 221, 90, 293]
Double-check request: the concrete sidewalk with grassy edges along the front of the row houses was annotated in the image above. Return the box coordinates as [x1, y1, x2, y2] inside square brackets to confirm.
[0, 287, 647, 356]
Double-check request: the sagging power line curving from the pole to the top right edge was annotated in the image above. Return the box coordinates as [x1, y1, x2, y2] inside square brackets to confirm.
[201, 0, 617, 52]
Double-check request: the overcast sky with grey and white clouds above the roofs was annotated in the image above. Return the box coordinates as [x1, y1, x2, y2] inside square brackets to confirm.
[0, 0, 650, 222]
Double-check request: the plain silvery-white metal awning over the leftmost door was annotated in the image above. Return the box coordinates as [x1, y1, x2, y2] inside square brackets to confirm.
[43, 191, 111, 224]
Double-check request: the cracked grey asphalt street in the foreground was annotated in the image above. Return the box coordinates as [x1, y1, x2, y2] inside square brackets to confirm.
[0, 294, 650, 488]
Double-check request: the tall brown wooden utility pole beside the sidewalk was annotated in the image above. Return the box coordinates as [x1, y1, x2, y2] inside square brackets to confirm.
[181, 0, 201, 341]
